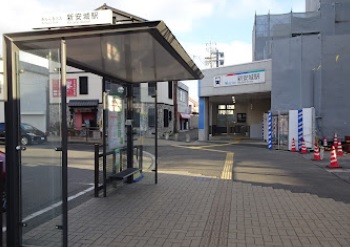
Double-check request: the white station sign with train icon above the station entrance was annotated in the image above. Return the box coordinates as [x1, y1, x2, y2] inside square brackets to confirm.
[214, 70, 265, 87]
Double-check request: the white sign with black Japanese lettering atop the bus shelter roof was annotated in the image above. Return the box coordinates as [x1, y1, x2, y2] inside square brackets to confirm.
[34, 10, 113, 28]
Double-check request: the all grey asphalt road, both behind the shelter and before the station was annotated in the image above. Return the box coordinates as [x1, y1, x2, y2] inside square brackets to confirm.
[2, 139, 350, 235]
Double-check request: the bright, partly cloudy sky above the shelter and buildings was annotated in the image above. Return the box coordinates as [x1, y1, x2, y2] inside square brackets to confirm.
[0, 0, 305, 98]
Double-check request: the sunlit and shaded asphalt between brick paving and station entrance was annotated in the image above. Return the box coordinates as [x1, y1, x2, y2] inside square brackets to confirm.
[159, 143, 350, 203]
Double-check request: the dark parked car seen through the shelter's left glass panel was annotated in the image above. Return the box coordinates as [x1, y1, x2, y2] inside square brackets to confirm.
[0, 123, 46, 146]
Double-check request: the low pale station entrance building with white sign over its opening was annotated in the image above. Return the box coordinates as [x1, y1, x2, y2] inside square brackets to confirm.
[199, 59, 272, 140]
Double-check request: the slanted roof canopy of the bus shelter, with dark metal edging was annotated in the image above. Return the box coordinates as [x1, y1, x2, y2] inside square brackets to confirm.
[4, 21, 203, 83]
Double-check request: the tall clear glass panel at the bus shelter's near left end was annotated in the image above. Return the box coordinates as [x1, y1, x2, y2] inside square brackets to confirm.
[17, 46, 63, 246]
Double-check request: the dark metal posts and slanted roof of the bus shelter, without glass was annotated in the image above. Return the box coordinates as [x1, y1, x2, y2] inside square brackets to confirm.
[3, 21, 203, 247]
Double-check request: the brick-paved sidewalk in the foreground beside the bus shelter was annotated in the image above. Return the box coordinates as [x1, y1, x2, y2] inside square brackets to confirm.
[22, 139, 350, 247]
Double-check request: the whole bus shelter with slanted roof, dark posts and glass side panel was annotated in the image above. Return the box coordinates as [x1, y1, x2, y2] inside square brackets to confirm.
[3, 21, 203, 247]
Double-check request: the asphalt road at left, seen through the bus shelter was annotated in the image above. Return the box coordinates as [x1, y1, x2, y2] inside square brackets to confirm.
[0, 143, 94, 231]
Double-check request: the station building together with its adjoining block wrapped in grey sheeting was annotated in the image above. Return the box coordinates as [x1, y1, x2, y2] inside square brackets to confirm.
[199, 0, 350, 149]
